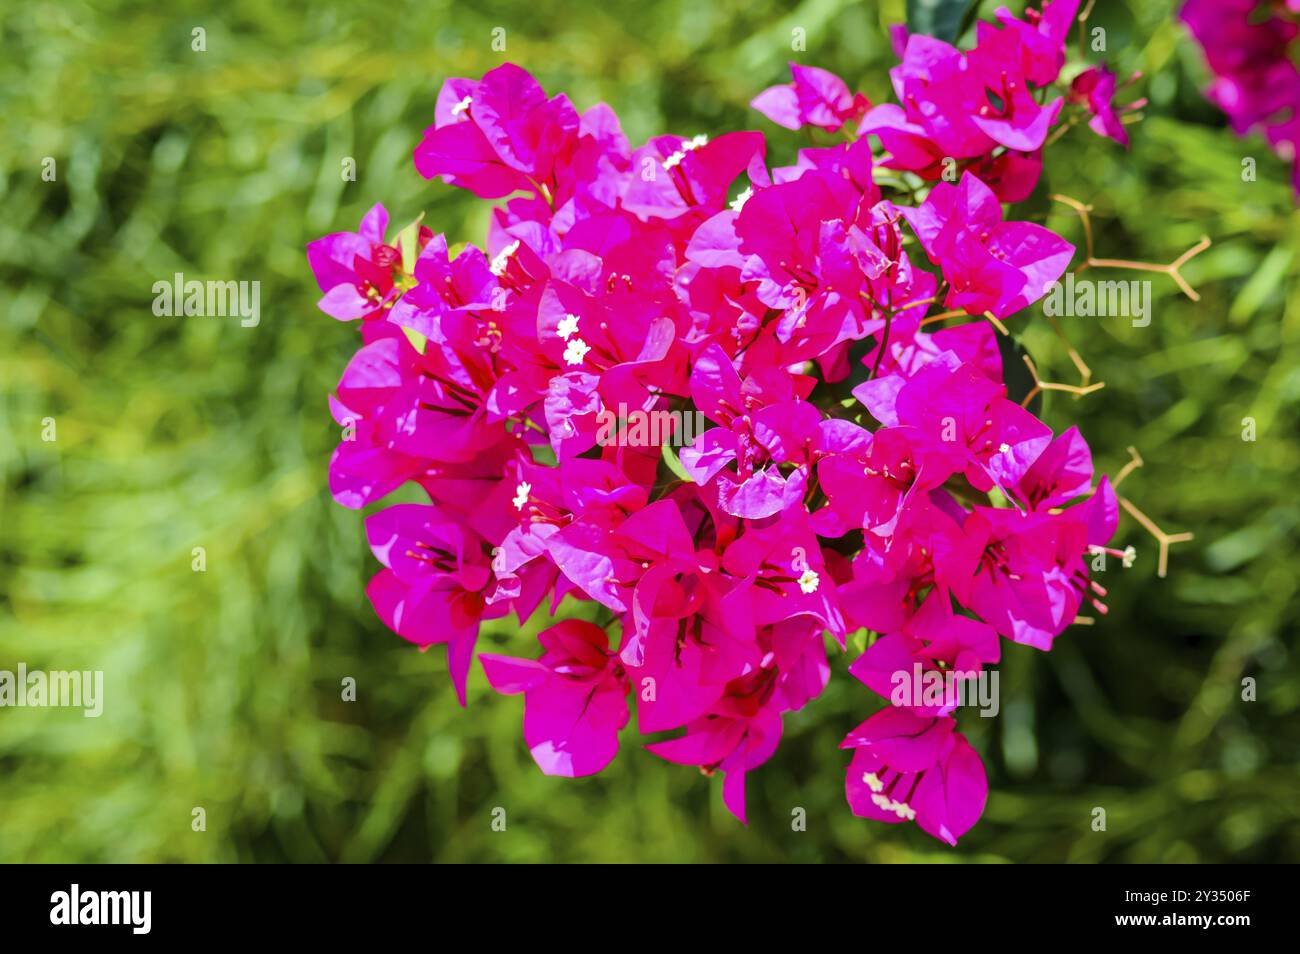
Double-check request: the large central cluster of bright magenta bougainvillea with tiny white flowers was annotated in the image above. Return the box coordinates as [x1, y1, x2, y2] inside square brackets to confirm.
[308, 0, 1138, 844]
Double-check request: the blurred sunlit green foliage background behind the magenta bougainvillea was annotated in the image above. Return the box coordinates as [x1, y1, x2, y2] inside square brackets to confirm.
[0, 0, 1300, 862]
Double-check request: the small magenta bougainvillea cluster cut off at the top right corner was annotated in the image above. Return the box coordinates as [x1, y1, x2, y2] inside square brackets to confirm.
[1180, 0, 1300, 196]
